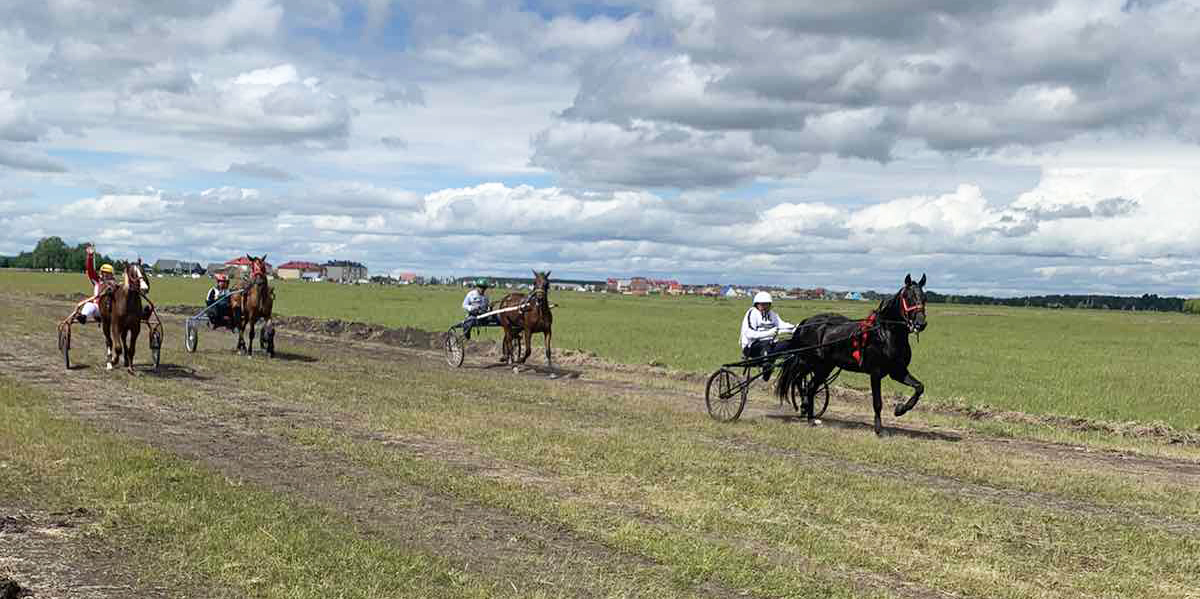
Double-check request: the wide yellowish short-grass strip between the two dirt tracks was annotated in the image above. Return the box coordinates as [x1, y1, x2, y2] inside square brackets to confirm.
[93, 338, 1200, 597]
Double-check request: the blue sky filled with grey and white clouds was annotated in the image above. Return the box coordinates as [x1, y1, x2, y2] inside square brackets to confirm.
[0, 0, 1200, 296]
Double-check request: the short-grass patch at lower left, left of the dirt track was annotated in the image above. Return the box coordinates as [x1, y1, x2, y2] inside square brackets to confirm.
[0, 375, 530, 599]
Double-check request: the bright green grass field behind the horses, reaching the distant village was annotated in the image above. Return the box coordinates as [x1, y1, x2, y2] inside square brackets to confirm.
[7, 271, 1200, 430]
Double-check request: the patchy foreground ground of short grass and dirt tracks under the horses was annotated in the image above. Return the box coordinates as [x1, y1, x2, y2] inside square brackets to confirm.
[0, 295, 1200, 599]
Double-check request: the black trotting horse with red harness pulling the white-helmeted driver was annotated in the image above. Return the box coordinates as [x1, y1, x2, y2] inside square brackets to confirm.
[775, 275, 925, 435]
